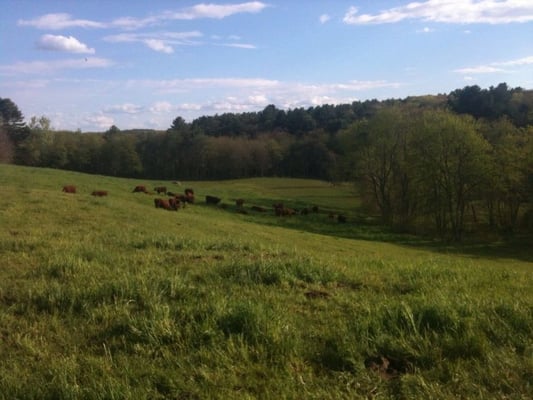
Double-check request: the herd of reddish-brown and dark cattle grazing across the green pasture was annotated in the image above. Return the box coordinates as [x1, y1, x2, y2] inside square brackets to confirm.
[63, 185, 347, 223]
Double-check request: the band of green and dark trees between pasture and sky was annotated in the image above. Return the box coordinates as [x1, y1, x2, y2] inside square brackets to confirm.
[0, 83, 533, 240]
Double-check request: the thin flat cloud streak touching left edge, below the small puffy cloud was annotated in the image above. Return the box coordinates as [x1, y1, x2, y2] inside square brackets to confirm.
[0, 57, 114, 75]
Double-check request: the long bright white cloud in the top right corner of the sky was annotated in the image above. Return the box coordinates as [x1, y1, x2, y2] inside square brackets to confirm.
[343, 0, 533, 25]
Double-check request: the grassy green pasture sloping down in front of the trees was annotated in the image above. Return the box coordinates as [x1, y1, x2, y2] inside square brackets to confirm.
[0, 165, 533, 399]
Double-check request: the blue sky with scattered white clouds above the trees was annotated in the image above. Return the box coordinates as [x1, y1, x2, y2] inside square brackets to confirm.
[0, 0, 533, 132]
